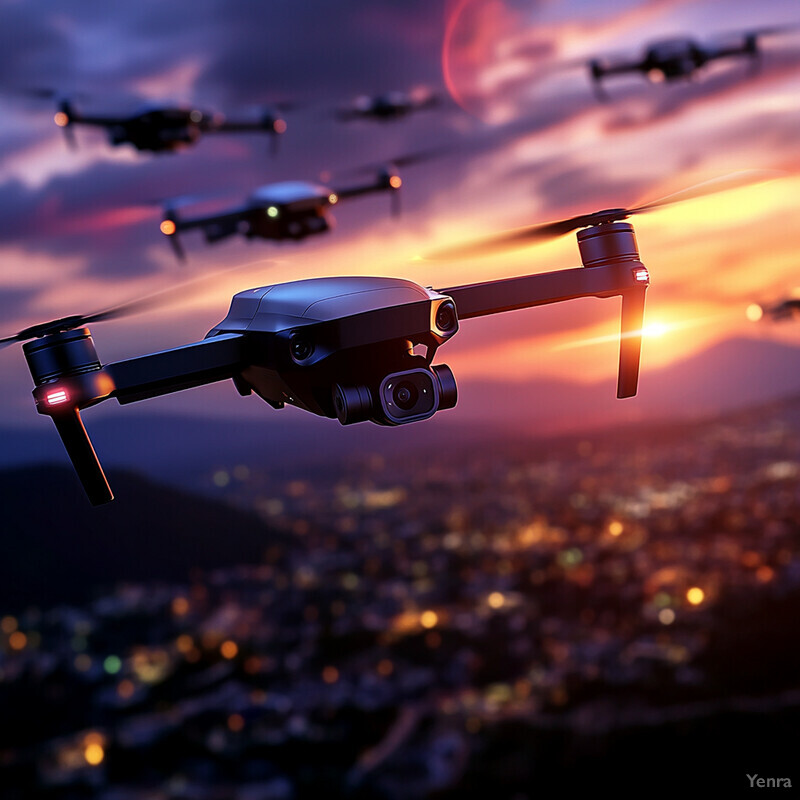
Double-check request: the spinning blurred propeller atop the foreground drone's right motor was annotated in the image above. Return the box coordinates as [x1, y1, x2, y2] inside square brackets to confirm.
[425, 169, 786, 261]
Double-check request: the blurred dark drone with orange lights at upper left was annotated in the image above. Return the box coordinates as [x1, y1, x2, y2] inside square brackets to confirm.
[44, 99, 286, 153]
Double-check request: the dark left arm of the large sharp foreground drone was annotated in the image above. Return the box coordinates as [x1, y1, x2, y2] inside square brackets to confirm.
[104, 333, 243, 405]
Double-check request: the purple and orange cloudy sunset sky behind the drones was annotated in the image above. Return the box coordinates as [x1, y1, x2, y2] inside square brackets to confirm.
[0, 0, 800, 426]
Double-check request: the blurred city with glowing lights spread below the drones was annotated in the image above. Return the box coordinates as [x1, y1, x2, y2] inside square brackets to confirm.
[0, 401, 800, 800]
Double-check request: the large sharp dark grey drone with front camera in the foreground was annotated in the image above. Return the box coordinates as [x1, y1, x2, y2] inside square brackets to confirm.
[0, 221, 649, 505]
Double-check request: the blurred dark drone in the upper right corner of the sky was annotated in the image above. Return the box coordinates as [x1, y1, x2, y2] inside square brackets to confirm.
[588, 27, 788, 100]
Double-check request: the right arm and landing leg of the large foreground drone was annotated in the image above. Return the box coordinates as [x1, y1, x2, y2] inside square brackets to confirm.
[438, 261, 649, 398]
